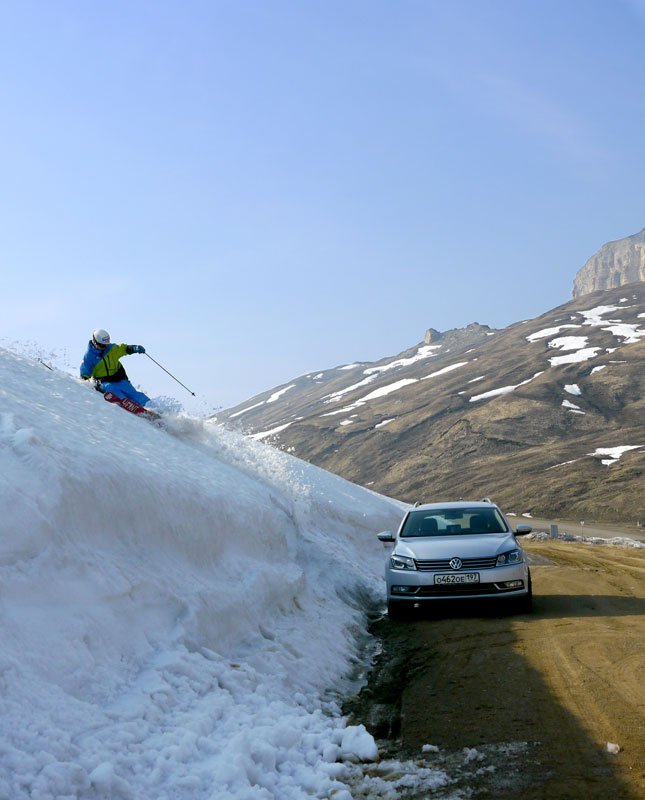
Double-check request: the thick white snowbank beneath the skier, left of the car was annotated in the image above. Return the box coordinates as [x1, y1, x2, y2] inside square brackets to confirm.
[0, 349, 412, 800]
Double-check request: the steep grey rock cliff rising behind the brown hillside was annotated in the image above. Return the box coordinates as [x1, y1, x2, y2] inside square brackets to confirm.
[573, 228, 645, 298]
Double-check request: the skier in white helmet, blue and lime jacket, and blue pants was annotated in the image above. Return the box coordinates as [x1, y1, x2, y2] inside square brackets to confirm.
[81, 328, 150, 406]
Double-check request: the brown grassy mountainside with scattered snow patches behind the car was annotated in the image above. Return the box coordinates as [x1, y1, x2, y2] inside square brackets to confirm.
[218, 282, 645, 523]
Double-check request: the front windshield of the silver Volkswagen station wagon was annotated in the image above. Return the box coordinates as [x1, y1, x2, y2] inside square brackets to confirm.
[399, 507, 508, 538]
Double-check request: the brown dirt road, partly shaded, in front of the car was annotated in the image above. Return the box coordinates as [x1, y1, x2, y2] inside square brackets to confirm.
[348, 541, 645, 800]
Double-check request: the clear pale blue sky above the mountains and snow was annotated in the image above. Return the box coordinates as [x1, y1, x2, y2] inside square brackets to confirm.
[0, 0, 645, 407]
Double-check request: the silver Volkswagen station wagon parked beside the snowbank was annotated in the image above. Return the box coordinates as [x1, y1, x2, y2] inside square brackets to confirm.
[378, 500, 532, 618]
